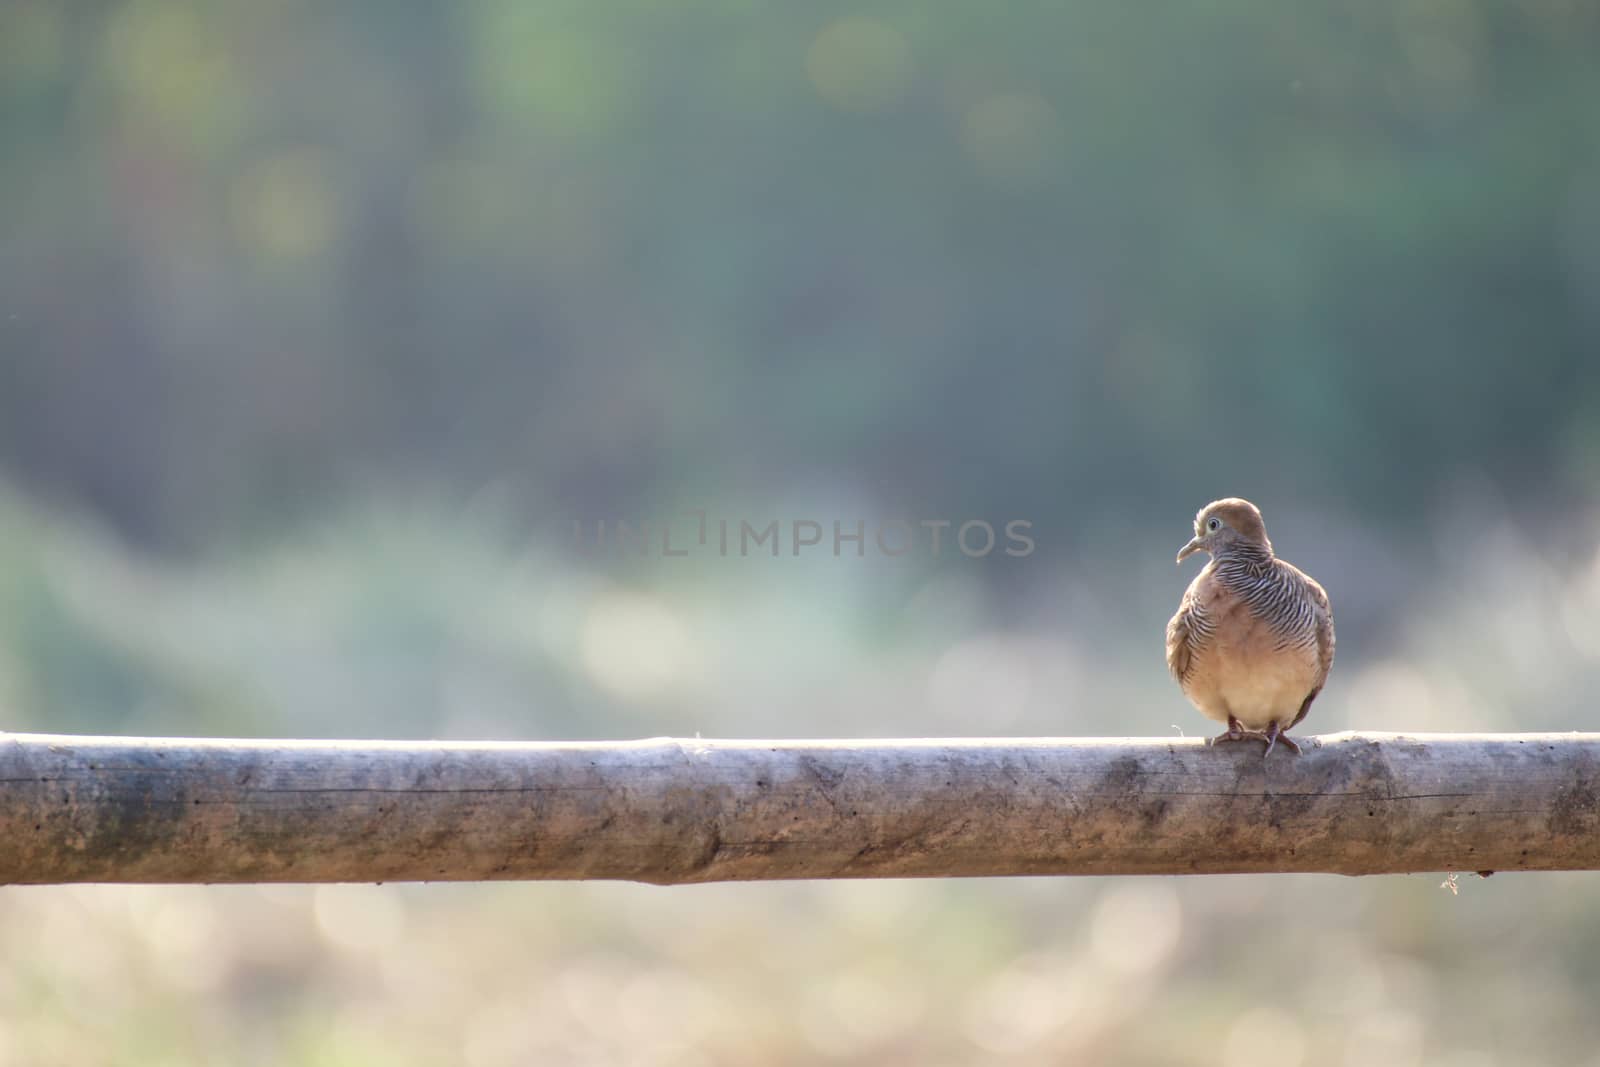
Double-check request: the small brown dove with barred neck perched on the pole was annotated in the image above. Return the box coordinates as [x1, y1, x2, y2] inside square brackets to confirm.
[1166, 496, 1333, 753]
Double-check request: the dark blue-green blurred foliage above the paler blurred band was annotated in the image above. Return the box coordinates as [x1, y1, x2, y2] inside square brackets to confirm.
[0, 0, 1600, 547]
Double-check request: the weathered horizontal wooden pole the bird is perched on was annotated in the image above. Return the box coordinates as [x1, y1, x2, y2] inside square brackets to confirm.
[0, 733, 1600, 885]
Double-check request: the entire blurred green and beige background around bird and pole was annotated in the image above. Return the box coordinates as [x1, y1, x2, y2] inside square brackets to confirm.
[0, 0, 1600, 1067]
